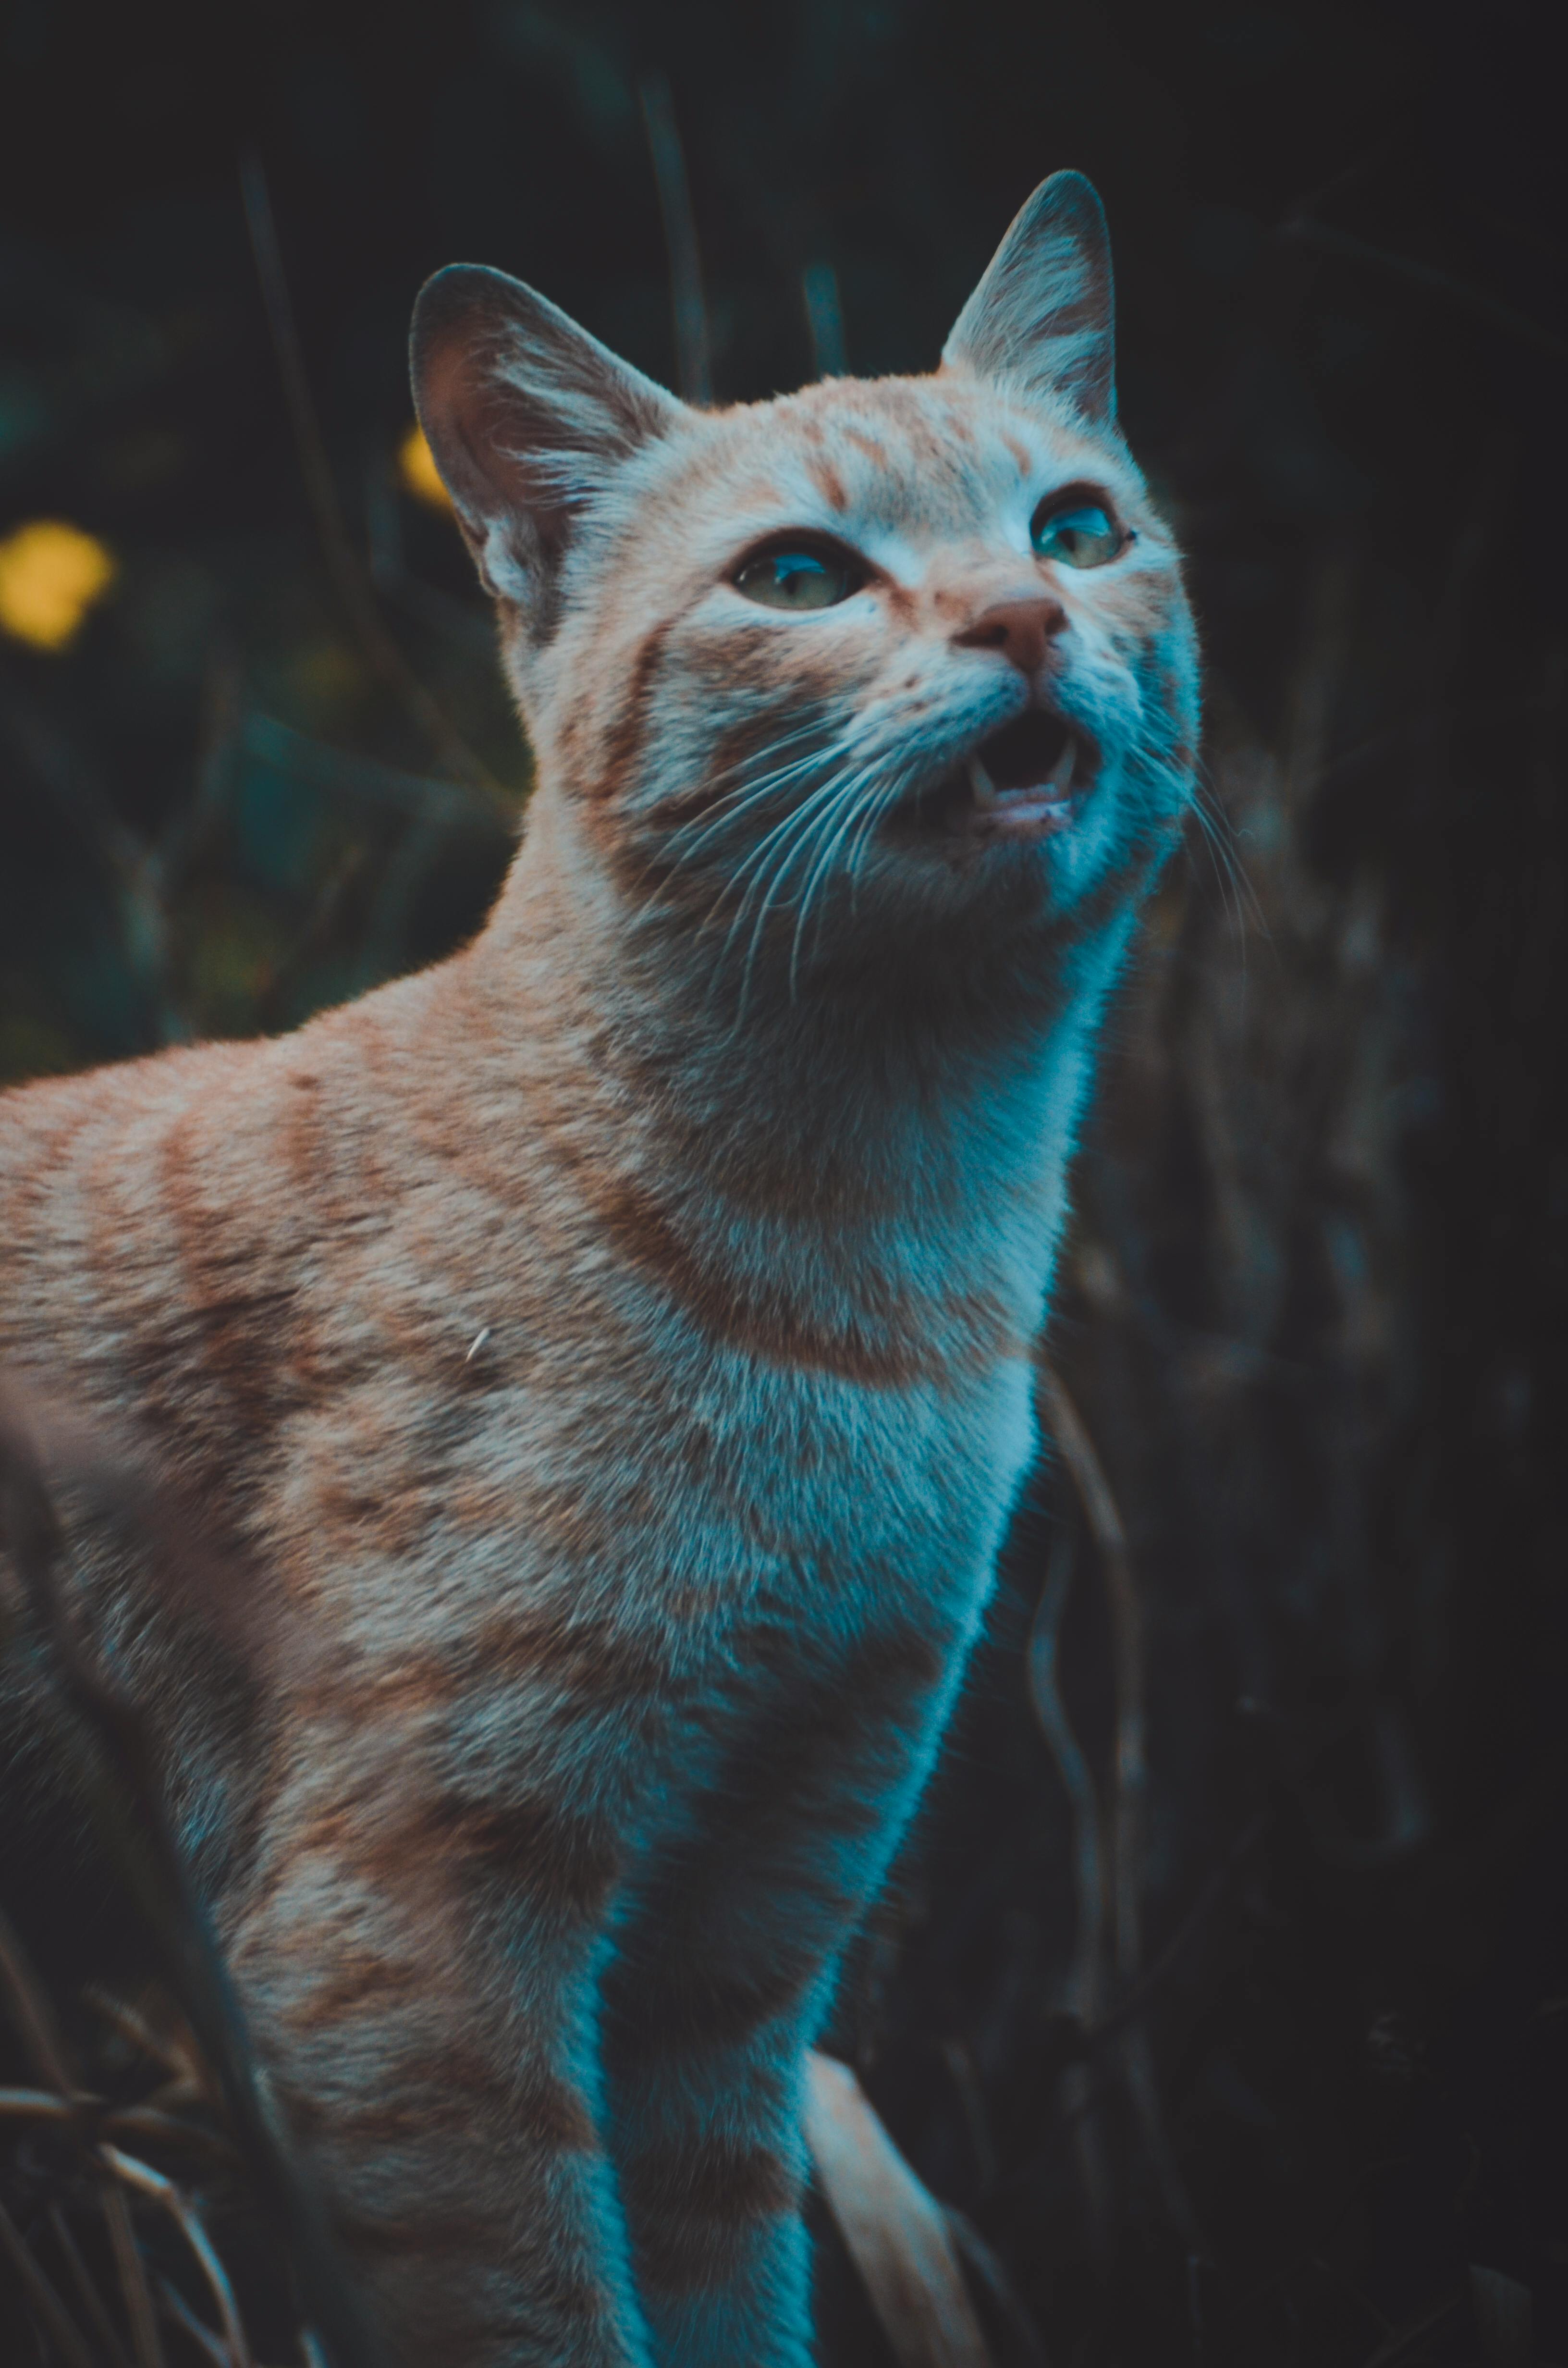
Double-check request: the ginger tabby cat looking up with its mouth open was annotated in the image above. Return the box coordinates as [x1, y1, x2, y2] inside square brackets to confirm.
[0, 173, 1199, 2368]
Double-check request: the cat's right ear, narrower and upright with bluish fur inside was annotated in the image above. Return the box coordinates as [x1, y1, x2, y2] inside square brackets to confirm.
[943, 173, 1115, 426]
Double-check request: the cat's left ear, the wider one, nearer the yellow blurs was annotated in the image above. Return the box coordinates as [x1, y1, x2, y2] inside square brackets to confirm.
[410, 263, 682, 632]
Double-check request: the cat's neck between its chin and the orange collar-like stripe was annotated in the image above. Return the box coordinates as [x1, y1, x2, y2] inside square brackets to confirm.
[469, 796, 1130, 1297]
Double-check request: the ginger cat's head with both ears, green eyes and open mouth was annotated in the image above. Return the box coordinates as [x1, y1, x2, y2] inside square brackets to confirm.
[412, 173, 1199, 992]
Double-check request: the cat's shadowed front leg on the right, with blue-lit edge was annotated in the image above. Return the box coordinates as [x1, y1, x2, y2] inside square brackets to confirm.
[604, 1605, 964, 2368]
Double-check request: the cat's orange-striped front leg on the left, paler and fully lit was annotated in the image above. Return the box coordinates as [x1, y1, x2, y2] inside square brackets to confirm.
[225, 1724, 651, 2368]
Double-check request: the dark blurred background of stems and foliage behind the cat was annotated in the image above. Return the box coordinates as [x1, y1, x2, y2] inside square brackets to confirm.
[0, 0, 1568, 2368]
